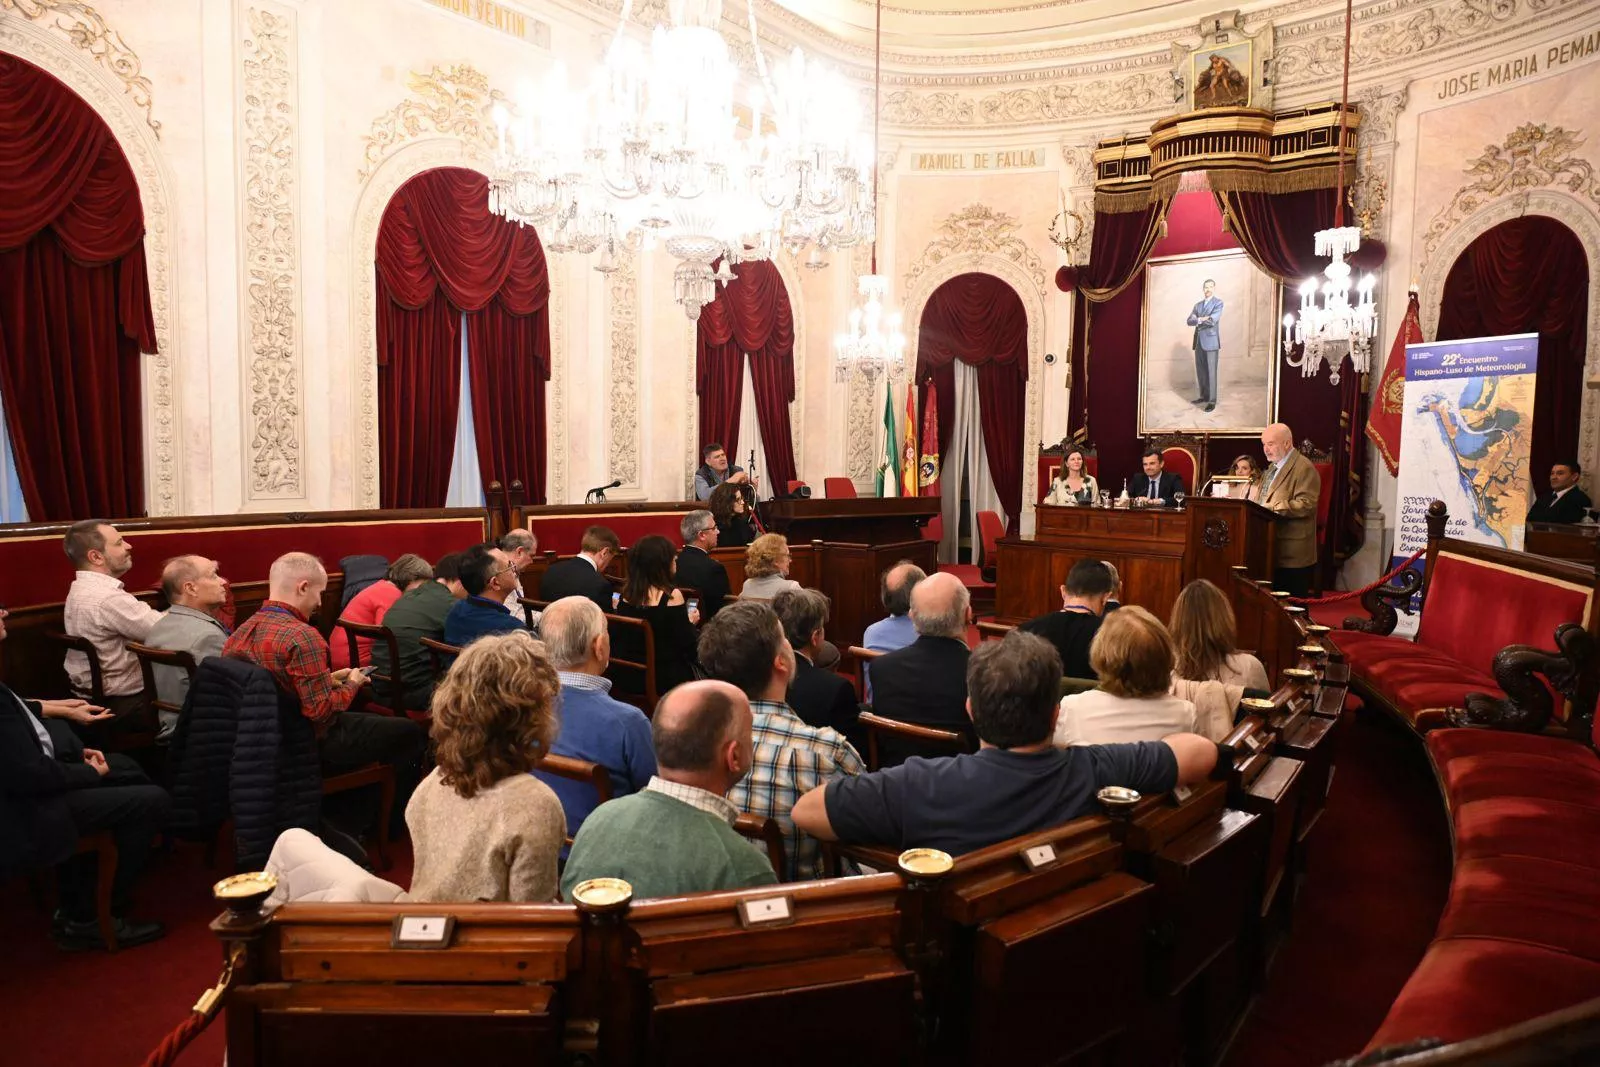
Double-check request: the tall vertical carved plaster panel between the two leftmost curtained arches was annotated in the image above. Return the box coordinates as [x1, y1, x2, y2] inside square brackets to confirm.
[235, 0, 306, 501]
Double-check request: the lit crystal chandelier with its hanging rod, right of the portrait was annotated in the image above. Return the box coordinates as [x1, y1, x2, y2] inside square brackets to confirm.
[1283, 0, 1378, 386]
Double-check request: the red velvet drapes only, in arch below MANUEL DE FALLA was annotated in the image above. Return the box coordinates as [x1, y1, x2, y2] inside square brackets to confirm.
[917, 274, 1027, 536]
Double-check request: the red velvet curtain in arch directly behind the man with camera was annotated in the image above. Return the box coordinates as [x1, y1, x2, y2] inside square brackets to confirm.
[694, 261, 795, 486]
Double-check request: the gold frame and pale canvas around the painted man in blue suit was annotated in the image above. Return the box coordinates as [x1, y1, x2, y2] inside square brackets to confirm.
[1138, 248, 1282, 437]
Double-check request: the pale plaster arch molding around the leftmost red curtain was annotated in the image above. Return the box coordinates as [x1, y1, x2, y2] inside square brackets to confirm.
[0, 17, 182, 515]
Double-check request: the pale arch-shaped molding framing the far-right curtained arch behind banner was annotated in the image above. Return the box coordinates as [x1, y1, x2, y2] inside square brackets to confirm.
[1419, 191, 1600, 489]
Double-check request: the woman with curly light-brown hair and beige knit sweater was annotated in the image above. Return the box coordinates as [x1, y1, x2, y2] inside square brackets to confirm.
[405, 630, 566, 902]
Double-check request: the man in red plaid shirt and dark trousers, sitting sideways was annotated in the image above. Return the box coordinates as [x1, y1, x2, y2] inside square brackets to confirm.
[222, 552, 422, 832]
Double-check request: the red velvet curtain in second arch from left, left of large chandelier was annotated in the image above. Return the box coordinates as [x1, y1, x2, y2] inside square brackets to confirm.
[376, 166, 550, 507]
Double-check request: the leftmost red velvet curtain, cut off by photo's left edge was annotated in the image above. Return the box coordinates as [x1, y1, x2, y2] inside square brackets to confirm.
[0, 54, 155, 522]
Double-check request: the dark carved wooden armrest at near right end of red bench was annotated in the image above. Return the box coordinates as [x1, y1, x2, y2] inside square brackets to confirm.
[1448, 622, 1600, 739]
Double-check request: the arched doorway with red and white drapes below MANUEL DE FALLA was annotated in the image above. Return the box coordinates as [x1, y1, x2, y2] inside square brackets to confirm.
[915, 272, 1027, 561]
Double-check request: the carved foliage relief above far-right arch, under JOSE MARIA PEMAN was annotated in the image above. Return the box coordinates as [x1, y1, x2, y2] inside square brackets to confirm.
[1422, 123, 1600, 266]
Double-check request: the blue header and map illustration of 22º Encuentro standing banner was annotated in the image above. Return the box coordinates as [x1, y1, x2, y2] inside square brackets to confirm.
[1394, 333, 1539, 629]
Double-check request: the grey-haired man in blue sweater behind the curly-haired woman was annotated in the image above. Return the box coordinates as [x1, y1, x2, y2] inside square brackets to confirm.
[534, 597, 656, 835]
